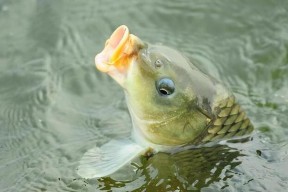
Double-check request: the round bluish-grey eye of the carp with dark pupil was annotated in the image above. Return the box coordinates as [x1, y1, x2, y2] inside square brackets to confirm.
[156, 78, 175, 96]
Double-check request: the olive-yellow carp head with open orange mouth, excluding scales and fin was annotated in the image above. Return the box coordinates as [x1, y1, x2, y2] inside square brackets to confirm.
[95, 26, 232, 146]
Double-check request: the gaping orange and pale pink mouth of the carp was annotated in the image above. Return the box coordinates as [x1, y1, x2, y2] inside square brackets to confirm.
[95, 25, 144, 87]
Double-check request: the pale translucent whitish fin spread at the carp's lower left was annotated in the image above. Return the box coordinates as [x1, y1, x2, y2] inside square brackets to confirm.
[77, 140, 145, 178]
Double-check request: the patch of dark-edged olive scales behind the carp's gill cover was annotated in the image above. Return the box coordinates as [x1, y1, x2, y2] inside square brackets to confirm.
[198, 96, 254, 143]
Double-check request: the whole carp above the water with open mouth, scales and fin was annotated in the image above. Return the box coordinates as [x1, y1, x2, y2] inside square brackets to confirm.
[78, 26, 253, 178]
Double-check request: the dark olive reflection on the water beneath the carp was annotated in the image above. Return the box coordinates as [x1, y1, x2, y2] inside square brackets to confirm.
[98, 144, 244, 191]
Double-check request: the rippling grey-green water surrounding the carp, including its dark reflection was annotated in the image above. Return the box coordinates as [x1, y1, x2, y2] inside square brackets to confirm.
[0, 0, 288, 192]
